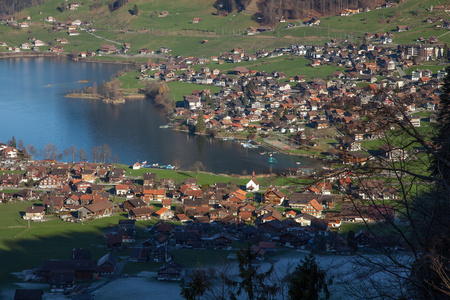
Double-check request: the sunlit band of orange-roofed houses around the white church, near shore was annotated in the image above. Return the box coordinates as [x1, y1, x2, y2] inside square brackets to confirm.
[0, 148, 398, 240]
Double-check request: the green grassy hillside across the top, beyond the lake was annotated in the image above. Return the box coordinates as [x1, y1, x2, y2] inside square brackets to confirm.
[0, 0, 450, 57]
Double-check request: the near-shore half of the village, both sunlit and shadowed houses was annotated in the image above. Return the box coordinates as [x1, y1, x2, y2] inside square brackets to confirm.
[0, 131, 412, 295]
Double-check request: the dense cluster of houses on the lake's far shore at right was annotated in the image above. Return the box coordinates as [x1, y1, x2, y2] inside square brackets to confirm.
[139, 39, 446, 162]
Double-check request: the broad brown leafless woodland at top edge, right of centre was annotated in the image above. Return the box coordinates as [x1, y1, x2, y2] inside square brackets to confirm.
[253, 0, 385, 25]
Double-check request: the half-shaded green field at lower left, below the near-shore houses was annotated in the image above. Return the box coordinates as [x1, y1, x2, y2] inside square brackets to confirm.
[0, 202, 130, 284]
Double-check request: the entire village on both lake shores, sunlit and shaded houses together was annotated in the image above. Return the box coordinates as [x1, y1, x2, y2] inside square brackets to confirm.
[0, 3, 450, 296]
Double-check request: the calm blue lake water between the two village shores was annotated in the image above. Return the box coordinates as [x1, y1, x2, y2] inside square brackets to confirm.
[0, 58, 316, 174]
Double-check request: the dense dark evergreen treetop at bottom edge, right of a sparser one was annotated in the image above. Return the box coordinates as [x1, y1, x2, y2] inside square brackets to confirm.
[288, 255, 331, 300]
